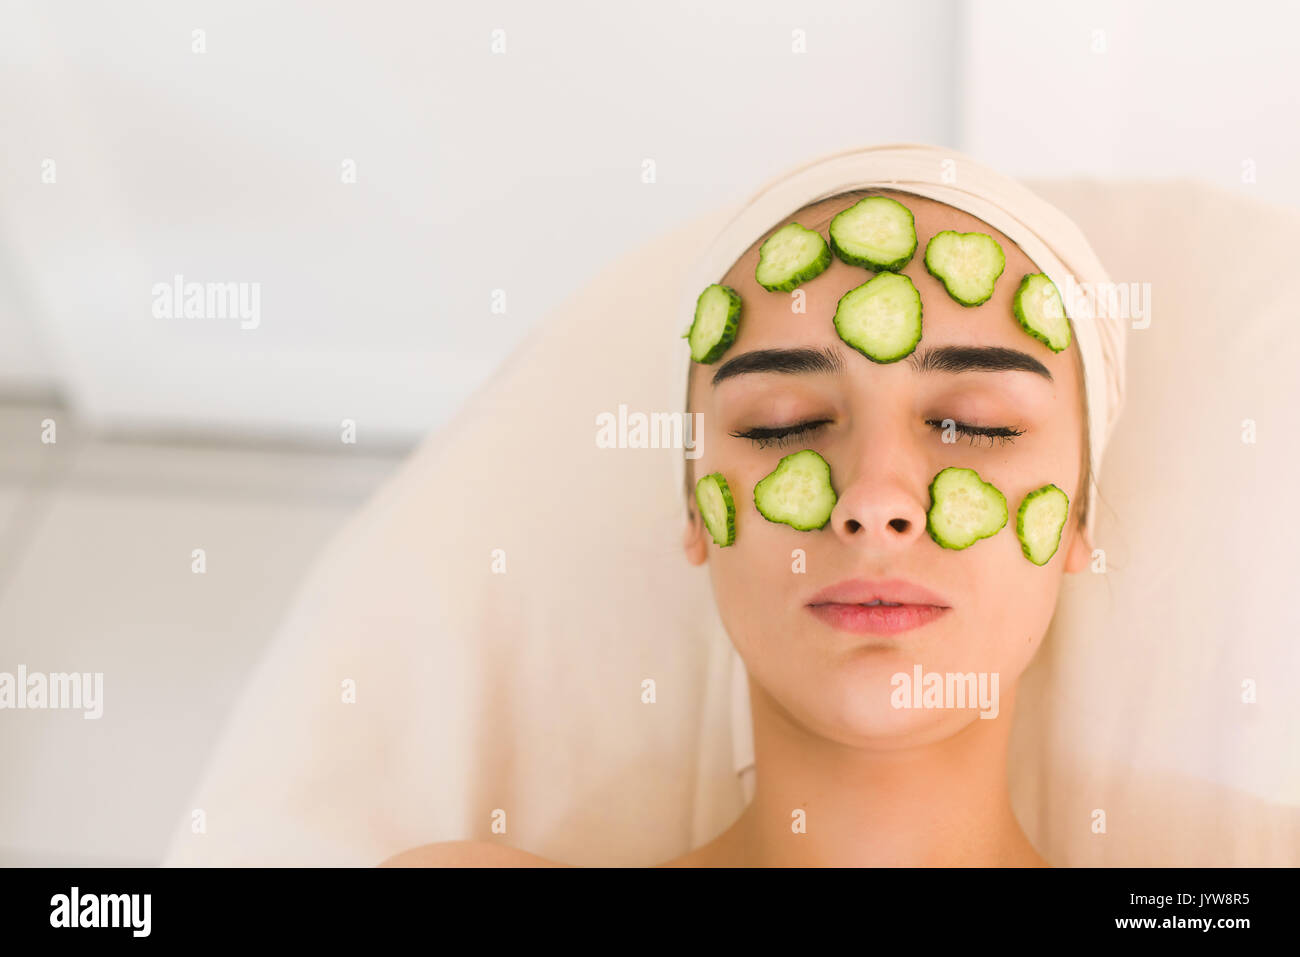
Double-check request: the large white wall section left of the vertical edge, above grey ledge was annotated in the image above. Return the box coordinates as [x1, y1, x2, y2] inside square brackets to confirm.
[0, 0, 956, 442]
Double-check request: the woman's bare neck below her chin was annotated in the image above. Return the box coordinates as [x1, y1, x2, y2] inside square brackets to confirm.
[735, 680, 1045, 867]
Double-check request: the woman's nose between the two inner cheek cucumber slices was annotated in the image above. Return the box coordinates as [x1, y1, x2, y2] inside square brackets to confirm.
[831, 449, 930, 550]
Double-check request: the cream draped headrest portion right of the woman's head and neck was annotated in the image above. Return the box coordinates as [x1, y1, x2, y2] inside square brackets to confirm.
[1011, 181, 1300, 866]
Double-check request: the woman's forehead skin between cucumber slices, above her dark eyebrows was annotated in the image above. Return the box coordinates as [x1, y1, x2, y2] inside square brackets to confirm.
[692, 190, 1079, 400]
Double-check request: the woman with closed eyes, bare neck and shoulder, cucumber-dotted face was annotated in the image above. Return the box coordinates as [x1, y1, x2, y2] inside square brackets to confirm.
[385, 143, 1115, 866]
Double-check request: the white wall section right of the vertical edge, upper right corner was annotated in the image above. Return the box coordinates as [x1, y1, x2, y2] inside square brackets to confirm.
[957, 0, 1300, 207]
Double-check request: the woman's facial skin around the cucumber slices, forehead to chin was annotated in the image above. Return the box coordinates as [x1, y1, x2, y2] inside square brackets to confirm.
[685, 191, 1089, 748]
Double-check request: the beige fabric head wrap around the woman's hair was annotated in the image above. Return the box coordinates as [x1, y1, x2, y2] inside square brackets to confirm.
[673, 143, 1126, 542]
